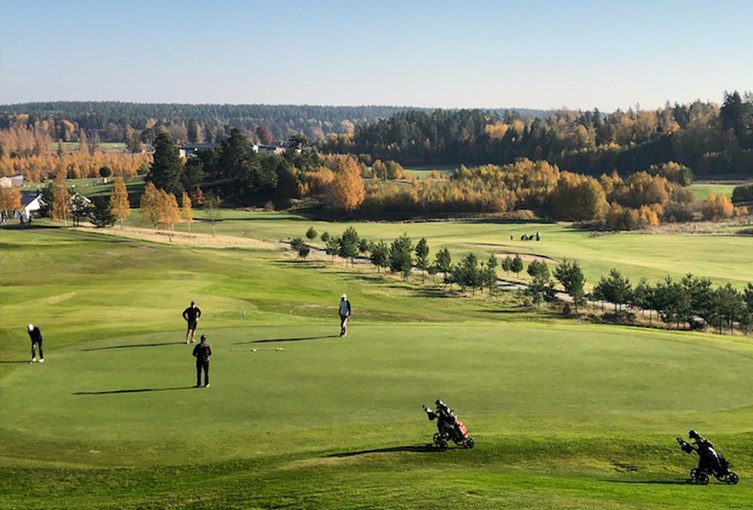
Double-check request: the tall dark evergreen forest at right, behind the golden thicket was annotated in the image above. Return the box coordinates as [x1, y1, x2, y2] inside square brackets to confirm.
[323, 92, 753, 176]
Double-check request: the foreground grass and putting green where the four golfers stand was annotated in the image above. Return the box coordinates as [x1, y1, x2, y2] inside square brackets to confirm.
[0, 229, 753, 509]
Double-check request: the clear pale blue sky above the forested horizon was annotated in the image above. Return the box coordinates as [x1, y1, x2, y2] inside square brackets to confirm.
[0, 0, 753, 111]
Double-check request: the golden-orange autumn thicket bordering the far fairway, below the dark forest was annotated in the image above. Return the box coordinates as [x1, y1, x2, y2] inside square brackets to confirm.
[358, 159, 747, 225]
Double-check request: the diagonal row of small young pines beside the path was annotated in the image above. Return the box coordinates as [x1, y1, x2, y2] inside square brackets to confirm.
[290, 227, 753, 334]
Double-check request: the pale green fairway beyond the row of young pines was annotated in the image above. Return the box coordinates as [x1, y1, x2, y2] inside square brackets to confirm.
[123, 210, 753, 289]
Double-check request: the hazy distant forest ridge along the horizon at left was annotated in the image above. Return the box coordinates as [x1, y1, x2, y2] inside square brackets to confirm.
[0, 101, 549, 143]
